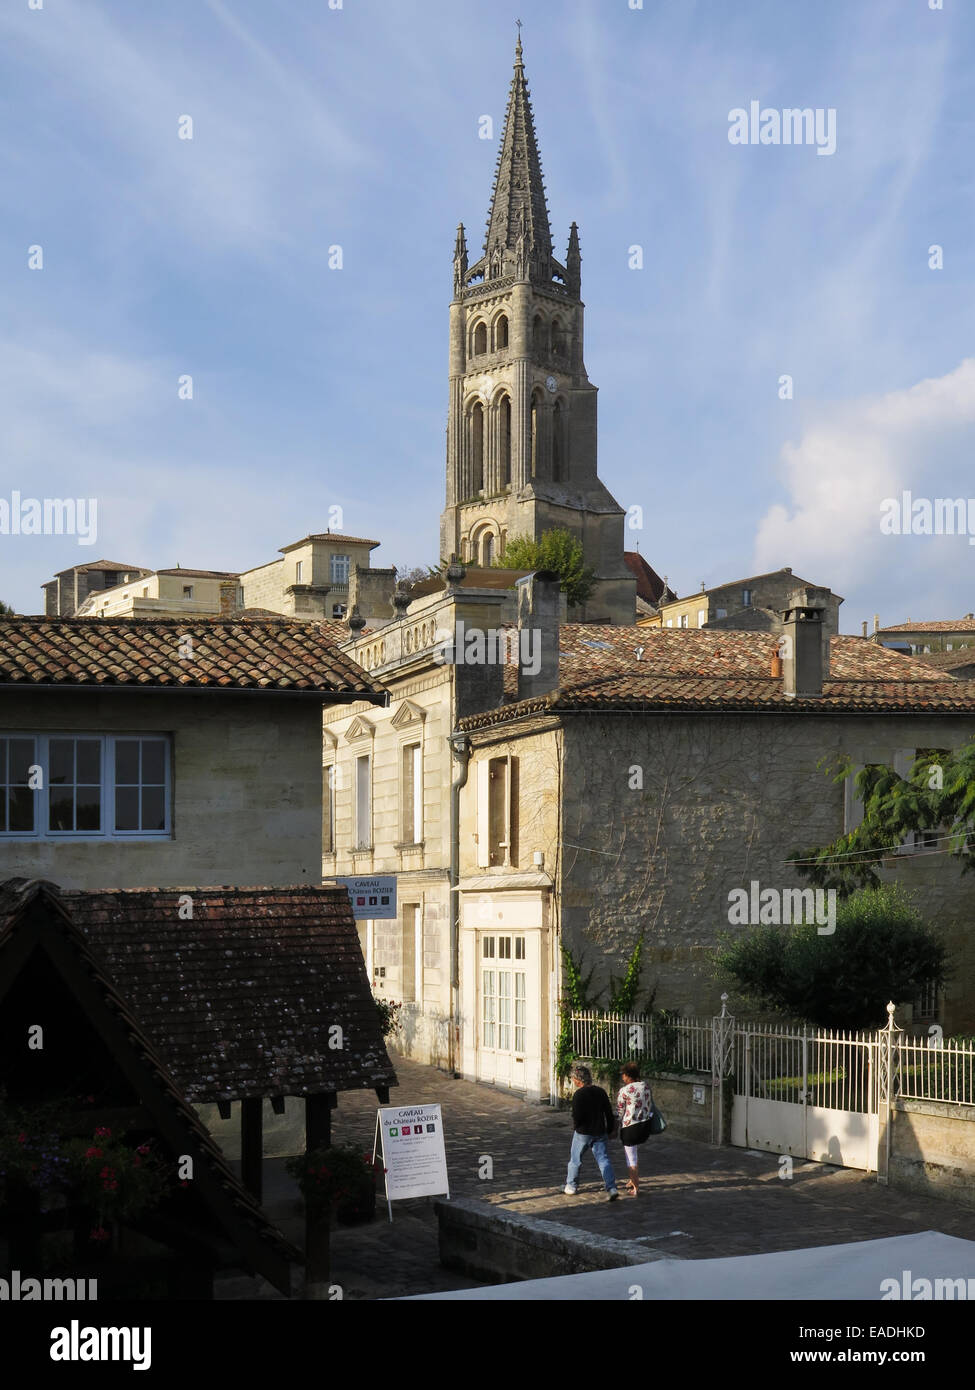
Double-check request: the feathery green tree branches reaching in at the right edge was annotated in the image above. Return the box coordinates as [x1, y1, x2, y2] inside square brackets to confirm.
[790, 738, 975, 894]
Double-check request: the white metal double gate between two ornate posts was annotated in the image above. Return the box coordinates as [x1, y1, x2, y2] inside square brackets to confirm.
[732, 1024, 882, 1172]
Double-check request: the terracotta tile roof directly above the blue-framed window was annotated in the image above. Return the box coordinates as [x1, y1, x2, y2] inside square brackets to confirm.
[0, 617, 387, 705]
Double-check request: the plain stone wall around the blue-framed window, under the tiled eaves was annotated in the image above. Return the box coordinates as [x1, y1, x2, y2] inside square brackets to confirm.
[0, 689, 321, 888]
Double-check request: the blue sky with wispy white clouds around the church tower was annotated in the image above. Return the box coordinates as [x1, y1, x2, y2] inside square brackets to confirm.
[0, 0, 975, 631]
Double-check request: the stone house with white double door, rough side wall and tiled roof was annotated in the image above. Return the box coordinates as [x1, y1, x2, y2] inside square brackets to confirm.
[458, 607, 975, 1098]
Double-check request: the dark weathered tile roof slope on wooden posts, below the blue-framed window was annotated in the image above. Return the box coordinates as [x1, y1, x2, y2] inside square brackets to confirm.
[30, 885, 396, 1104]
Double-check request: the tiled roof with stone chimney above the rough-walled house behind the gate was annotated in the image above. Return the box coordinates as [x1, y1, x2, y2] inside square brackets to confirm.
[460, 623, 975, 730]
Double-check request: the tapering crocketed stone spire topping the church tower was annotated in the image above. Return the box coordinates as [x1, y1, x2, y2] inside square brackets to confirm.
[484, 33, 552, 279]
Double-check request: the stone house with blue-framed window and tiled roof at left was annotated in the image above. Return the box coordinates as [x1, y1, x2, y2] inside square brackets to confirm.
[0, 617, 387, 888]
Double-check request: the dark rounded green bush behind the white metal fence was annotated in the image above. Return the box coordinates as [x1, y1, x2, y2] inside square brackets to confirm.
[716, 884, 950, 1029]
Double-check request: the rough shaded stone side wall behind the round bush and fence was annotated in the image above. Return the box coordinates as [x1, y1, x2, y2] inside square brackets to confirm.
[561, 713, 975, 1033]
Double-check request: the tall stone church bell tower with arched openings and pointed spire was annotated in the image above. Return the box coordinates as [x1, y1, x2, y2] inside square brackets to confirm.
[441, 36, 636, 623]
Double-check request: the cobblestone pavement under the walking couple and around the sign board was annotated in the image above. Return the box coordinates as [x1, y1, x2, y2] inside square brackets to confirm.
[248, 1056, 975, 1298]
